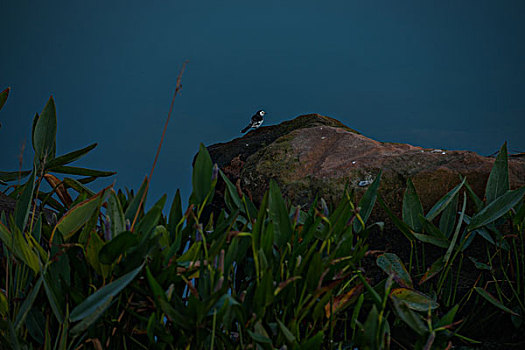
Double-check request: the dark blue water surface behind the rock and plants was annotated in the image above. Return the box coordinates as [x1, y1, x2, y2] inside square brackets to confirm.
[0, 0, 525, 205]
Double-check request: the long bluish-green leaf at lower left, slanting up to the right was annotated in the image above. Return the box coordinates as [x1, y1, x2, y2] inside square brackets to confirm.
[69, 264, 144, 322]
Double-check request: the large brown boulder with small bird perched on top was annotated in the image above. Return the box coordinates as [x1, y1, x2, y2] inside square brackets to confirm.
[208, 114, 525, 219]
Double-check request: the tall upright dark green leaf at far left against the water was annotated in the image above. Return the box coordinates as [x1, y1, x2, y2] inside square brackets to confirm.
[33, 97, 57, 162]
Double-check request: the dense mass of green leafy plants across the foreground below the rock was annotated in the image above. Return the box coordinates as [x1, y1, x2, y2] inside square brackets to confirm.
[0, 90, 525, 349]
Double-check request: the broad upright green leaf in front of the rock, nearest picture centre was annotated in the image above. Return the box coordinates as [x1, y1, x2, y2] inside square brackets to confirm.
[269, 180, 292, 248]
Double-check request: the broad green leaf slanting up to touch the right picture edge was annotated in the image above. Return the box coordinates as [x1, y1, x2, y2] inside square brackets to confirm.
[467, 187, 525, 231]
